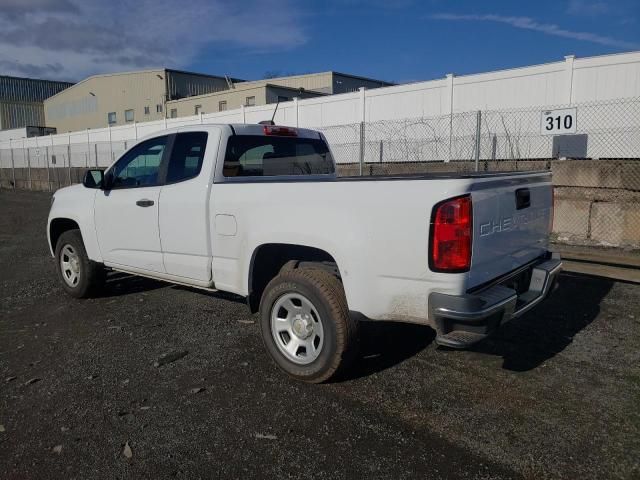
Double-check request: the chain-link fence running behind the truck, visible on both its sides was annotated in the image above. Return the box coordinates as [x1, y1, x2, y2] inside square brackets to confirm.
[0, 98, 640, 248]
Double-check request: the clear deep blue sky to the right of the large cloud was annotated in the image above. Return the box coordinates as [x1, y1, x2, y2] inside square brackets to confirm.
[196, 0, 640, 82]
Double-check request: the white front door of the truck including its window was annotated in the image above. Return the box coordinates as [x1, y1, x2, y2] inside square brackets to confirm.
[94, 135, 171, 273]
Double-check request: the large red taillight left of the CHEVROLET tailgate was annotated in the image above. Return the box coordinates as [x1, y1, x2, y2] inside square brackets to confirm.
[429, 195, 473, 273]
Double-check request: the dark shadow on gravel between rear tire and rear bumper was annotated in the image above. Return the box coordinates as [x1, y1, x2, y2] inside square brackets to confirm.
[337, 320, 436, 382]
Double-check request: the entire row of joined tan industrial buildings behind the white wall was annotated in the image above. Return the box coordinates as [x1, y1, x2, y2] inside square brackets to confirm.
[44, 69, 392, 132]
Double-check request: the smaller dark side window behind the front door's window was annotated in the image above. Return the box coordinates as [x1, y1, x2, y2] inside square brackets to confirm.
[167, 132, 208, 183]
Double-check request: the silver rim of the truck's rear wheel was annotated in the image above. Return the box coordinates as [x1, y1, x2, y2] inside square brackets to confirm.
[271, 293, 324, 365]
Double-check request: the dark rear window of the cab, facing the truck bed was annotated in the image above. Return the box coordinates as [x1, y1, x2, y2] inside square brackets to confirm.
[223, 135, 335, 177]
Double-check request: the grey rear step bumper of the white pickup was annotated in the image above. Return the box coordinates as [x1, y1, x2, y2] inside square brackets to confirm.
[429, 258, 562, 348]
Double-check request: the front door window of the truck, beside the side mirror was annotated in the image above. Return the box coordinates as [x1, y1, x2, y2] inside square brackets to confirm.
[111, 136, 167, 188]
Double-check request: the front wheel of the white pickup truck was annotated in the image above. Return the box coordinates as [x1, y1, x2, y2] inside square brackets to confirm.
[56, 230, 105, 298]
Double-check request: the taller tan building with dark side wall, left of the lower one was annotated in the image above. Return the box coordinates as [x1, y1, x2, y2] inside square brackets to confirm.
[44, 68, 242, 132]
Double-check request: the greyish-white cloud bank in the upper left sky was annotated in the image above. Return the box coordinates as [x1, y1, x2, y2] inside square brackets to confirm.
[0, 0, 307, 80]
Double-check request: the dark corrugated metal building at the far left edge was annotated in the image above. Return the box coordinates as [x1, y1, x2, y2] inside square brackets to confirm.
[0, 75, 73, 130]
